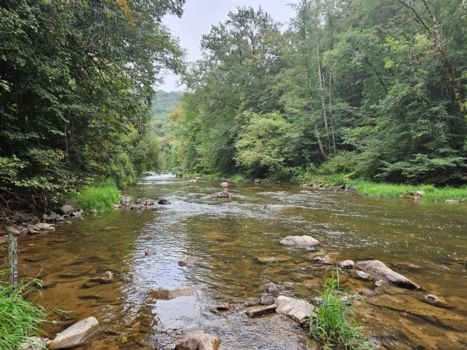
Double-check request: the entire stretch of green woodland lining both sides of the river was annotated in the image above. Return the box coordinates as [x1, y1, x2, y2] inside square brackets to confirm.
[0, 0, 467, 213]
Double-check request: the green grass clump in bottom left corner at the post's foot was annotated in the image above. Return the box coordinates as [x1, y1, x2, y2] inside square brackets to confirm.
[0, 278, 45, 350]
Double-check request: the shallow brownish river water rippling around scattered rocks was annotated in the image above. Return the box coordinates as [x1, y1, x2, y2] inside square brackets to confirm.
[11, 176, 467, 350]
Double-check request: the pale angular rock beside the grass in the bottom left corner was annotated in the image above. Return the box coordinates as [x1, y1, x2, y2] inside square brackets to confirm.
[49, 317, 99, 349]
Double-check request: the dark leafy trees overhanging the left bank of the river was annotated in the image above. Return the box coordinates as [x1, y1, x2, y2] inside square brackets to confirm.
[0, 0, 184, 208]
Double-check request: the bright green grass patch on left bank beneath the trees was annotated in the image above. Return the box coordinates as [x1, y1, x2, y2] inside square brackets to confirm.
[71, 180, 120, 211]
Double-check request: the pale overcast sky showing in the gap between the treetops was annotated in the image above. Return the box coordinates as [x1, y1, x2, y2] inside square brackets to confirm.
[158, 0, 298, 91]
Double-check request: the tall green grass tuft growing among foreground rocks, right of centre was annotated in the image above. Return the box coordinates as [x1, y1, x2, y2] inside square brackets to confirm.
[310, 271, 372, 350]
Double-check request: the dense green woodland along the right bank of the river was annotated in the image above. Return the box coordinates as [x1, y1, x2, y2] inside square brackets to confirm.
[169, 0, 467, 185]
